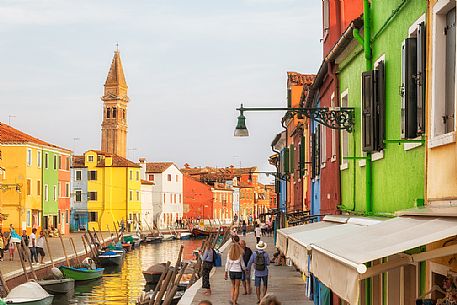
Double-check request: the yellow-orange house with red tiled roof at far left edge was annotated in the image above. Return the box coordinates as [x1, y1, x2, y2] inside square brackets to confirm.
[0, 123, 71, 233]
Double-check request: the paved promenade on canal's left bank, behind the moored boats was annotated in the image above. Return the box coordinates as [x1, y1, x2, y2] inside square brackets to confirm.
[0, 233, 109, 280]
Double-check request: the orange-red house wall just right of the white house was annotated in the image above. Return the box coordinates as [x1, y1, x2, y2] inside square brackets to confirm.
[183, 174, 213, 219]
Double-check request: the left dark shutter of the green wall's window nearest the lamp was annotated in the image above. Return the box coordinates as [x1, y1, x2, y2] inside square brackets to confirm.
[362, 71, 375, 152]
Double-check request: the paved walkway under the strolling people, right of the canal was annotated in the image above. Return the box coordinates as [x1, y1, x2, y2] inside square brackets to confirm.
[179, 234, 313, 305]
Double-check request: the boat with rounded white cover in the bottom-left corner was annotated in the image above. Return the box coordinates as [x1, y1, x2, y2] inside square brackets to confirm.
[3, 282, 54, 305]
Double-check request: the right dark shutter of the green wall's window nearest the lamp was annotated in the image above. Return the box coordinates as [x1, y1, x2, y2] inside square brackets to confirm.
[374, 61, 386, 151]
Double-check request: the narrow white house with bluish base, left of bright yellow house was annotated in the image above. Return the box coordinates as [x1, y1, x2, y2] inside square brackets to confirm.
[70, 156, 89, 232]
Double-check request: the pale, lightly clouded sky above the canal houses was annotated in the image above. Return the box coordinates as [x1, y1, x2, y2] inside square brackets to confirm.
[0, 0, 322, 180]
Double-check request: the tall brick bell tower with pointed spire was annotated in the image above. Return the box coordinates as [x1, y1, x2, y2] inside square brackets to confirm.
[101, 50, 129, 158]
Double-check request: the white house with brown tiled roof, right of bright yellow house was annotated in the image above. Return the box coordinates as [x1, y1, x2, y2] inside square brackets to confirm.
[140, 159, 183, 228]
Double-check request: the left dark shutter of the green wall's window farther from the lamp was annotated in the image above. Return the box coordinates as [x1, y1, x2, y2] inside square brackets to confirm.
[401, 38, 417, 139]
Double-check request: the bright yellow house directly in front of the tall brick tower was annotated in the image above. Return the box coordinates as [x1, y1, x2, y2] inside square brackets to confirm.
[84, 150, 141, 231]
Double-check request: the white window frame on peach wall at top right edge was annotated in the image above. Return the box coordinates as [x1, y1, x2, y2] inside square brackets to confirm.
[428, 0, 457, 148]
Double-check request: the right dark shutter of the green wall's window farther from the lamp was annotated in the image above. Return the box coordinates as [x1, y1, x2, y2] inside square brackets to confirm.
[416, 22, 427, 134]
